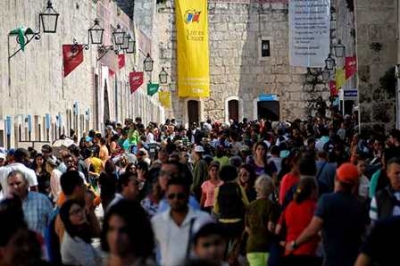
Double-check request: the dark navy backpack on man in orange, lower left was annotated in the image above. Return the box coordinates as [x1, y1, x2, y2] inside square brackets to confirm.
[45, 207, 61, 265]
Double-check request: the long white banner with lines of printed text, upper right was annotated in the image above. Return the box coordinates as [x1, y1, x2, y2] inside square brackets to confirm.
[289, 0, 331, 67]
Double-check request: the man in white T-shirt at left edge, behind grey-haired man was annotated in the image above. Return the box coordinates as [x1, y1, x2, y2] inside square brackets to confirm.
[0, 148, 38, 195]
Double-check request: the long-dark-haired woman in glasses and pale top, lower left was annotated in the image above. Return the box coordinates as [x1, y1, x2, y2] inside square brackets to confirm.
[60, 200, 101, 266]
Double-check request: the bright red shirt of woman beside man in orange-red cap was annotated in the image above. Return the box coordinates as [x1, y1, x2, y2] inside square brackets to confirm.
[281, 199, 319, 256]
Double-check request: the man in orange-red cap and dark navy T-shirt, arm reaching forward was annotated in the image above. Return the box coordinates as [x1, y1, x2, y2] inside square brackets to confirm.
[286, 163, 368, 266]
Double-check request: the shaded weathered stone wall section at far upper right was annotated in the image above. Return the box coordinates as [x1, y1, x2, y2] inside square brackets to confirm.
[355, 0, 398, 129]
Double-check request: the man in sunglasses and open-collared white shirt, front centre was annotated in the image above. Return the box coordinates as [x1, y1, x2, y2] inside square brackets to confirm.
[151, 177, 212, 266]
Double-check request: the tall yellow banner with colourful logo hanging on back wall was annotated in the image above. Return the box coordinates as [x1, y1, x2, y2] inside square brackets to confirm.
[175, 0, 210, 97]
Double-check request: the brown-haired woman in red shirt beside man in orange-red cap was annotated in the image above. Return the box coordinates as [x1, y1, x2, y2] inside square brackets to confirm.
[276, 177, 321, 266]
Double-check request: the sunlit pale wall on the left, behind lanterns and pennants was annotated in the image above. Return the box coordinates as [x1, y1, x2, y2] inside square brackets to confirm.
[0, 0, 164, 147]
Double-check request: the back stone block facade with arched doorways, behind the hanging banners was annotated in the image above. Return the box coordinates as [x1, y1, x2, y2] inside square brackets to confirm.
[141, 0, 329, 126]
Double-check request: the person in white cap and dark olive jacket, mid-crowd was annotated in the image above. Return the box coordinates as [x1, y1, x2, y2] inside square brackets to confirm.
[191, 145, 208, 202]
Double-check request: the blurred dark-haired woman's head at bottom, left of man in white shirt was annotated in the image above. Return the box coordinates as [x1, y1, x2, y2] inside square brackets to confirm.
[101, 199, 155, 266]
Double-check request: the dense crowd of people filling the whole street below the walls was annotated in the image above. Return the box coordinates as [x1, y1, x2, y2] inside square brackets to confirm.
[0, 114, 400, 266]
